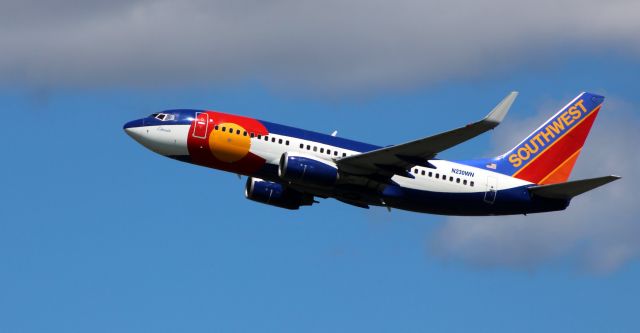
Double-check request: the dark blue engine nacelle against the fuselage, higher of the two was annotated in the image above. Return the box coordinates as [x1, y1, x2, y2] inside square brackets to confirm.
[278, 152, 340, 187]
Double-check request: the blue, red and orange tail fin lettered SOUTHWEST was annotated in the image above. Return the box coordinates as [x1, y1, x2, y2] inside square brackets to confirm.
[495, 92, 604, 184]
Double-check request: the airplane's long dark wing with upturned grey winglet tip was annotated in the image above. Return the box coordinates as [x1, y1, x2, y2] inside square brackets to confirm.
[336, 91, 518, 177]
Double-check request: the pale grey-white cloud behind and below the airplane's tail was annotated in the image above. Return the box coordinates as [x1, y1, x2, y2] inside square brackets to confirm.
[429, 96, 640, 272]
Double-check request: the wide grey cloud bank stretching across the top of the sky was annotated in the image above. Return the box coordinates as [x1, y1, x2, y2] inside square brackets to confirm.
[0, 0, 640, 92]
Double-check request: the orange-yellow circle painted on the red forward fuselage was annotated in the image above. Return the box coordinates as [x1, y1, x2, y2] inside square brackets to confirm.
[209, 123, 251, 163]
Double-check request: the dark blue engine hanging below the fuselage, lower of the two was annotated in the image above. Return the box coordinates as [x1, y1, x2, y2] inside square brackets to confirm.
[244, 177, 313, 209]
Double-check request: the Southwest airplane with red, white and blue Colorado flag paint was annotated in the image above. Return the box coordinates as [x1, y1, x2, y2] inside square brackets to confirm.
[124, 91, 620, 216]
